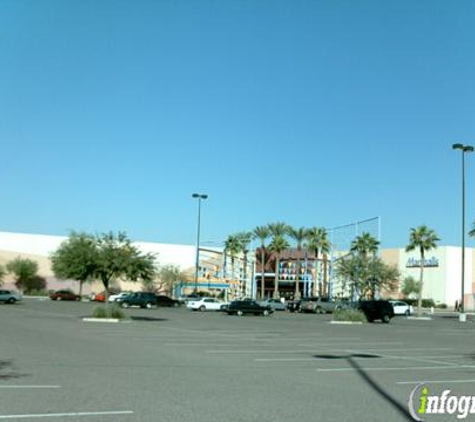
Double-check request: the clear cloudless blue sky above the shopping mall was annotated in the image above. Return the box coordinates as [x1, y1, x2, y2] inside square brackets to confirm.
[0, 0, 475, 248]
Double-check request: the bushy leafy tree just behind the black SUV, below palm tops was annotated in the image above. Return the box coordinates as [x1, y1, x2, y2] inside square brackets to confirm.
[336, 255, 400, 298]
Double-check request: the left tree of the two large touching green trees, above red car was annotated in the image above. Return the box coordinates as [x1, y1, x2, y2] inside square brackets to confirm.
[50, 231, 98, 296]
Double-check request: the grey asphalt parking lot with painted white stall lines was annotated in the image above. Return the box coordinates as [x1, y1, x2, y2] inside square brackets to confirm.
[0, 299, 475, 422]
